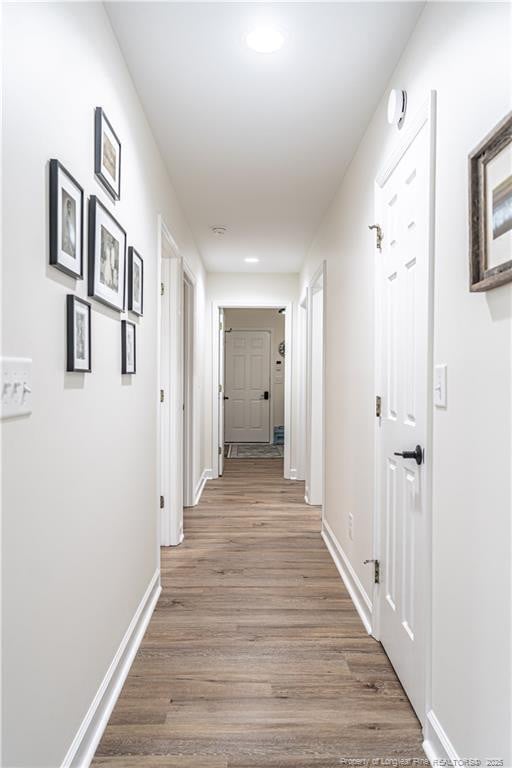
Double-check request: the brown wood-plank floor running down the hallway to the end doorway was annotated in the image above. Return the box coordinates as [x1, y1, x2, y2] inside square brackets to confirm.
[93, 459, 425, 768]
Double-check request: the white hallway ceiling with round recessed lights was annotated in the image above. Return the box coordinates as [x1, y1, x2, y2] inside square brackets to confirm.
[107, 2, 422, 272]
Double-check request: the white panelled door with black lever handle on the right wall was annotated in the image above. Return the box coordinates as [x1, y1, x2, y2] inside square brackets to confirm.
[376, 94, 432, 720]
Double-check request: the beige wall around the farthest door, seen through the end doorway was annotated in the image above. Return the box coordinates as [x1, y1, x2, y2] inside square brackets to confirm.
[224, 309, 286, 440]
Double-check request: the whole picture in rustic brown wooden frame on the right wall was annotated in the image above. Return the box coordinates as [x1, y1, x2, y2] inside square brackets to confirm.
[469, 112, 512, 291]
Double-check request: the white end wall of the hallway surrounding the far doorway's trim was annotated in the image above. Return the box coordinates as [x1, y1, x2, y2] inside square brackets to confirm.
[203, 272, 300, 476]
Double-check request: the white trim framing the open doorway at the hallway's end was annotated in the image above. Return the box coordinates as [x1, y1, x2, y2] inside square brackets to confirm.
[211, 301, 293, 480]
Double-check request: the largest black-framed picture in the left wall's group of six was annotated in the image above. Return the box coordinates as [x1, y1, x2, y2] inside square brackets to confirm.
[88, 195, 126, 312]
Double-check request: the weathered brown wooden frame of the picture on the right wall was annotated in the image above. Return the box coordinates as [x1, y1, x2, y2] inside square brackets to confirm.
[468, 112, 512, 292]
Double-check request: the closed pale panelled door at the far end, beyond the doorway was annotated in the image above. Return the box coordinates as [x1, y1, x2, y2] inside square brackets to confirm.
[224, 331, 270, 443]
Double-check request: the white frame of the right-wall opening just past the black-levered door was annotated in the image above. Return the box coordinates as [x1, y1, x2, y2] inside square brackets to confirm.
[304, 259, 327, 526]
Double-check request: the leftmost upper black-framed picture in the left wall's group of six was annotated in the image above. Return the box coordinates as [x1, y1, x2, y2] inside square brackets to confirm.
[50, 160, 84, 280]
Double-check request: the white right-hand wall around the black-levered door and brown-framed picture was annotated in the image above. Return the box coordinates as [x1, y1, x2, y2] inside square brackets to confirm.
[302, 3, 512, 766]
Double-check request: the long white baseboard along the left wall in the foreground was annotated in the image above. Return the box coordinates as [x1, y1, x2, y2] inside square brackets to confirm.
[61, 569, 162, 768]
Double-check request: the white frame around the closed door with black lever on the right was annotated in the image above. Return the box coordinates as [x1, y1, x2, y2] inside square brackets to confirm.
[371, 91, 436, 730]
